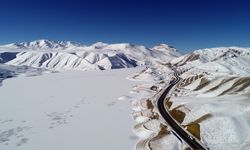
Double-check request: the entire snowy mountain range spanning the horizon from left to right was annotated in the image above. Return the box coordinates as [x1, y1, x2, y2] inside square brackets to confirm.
[0, 40, 250, 75]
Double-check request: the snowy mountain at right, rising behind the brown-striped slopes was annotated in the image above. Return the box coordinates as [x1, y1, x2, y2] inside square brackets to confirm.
[171, 47, 250, 75]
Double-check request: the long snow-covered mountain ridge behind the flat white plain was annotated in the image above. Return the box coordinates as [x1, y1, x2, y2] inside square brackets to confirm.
[0, 40, 180, 70]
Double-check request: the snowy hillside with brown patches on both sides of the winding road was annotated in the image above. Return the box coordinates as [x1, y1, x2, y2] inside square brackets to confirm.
[131, 47, 250, 150]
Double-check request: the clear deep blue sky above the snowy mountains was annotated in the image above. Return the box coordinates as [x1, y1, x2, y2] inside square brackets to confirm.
[0, 0, 250, 52]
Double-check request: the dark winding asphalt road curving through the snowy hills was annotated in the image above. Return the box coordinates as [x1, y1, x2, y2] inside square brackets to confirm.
[157, 69, 207, 150]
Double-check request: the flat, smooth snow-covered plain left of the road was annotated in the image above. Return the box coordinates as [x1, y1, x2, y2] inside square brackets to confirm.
[0, 68, 142, 150]
